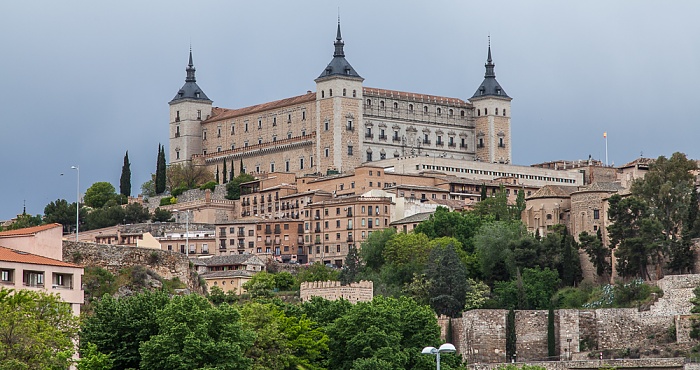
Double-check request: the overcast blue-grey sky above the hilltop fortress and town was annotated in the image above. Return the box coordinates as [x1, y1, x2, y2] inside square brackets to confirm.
[0, 0, 700, 220]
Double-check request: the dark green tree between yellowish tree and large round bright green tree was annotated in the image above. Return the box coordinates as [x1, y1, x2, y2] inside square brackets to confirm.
[80, 291, 171, 369]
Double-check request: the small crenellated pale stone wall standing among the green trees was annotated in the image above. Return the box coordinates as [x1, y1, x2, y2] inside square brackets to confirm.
[299, 280, 374, 303]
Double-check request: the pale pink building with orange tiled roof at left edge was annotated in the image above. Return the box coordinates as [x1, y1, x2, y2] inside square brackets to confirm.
[0, 224, 84, 315]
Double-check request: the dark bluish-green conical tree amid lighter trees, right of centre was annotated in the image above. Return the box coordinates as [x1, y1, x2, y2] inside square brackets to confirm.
[425, 244, 469, 317]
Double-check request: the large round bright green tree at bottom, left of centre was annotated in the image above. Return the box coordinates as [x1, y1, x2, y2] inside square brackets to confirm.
[139, 294, 254, 370]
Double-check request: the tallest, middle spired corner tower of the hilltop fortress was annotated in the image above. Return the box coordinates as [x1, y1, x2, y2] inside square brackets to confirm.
[314, 19, 364, 174]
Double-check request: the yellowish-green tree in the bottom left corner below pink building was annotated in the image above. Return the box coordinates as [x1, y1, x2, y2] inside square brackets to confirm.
[0, 287, 78, 369]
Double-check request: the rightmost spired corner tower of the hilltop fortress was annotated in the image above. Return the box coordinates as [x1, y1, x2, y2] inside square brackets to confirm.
[469, 39, 513, 163]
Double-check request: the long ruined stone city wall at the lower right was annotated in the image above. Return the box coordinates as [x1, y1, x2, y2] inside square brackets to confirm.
[452, 275, 700, 363]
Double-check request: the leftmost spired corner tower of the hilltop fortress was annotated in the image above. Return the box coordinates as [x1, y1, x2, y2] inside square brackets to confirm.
[168, 49, 212, 164]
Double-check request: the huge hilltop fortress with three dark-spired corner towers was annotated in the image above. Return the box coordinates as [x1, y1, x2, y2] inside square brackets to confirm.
[169, 22, 512, 178]
